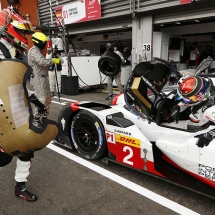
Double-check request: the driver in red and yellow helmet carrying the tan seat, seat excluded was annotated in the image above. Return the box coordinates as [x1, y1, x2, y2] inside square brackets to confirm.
[0, 7, 57, 202]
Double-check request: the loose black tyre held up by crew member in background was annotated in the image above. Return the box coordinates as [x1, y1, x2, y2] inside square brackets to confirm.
[98, 51, 122, 76]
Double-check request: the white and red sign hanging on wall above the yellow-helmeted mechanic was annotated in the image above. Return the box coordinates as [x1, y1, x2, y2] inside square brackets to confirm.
[55, 0, 101, 26]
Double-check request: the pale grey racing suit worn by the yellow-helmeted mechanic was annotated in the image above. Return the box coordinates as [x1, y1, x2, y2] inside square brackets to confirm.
[28, 46, 53, 116]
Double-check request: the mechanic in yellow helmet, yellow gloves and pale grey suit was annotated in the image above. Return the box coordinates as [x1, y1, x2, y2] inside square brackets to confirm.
[28, 32, 60, 121]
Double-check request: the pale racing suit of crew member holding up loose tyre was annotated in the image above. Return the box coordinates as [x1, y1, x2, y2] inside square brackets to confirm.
[107, 51, 125, 95]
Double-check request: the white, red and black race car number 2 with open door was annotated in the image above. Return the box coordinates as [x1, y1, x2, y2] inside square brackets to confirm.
[55, 58, 215, 198]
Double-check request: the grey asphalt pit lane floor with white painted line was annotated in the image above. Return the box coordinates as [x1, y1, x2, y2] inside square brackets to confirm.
[0, 92, 215, 215]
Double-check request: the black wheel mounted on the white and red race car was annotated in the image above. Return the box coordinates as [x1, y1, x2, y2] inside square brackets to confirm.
[71, 110, 107, 160]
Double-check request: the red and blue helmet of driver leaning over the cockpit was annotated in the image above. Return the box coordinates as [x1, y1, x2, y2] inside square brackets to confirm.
[176, 76, 210, 105]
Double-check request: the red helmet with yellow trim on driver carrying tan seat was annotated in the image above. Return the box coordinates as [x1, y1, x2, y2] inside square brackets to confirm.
[0, 8, 34, 51]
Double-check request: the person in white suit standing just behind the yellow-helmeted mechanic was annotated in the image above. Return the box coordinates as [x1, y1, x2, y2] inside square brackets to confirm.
[46, 45, 64, 97]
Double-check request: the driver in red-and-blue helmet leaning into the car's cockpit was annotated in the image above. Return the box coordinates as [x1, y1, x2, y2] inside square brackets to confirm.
[169, 76, 215, 148]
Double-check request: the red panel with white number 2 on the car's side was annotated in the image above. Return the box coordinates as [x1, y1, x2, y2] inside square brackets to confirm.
[116, 142, 144, 169]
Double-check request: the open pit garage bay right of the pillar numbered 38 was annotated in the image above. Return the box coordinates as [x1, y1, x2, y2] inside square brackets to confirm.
[153, 0, 215, 71]
